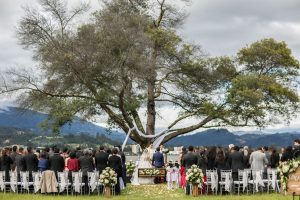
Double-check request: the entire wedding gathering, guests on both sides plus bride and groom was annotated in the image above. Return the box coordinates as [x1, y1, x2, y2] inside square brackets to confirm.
[0, 139, 300, 194]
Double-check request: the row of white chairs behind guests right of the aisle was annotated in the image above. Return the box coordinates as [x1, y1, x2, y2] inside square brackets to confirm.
[190, 169, 280, 195]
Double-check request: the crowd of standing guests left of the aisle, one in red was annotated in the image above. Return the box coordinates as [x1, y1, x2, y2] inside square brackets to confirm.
[0, 146, 126, 194]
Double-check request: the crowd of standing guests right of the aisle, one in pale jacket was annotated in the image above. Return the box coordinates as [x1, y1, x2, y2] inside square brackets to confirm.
[179, 139, 300, 194]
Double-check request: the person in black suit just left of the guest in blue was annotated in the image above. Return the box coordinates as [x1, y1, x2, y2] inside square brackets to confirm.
[23, 147, 39, 181]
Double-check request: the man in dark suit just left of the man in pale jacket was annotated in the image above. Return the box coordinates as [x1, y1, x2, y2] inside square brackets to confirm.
[228, 146, 246, 181]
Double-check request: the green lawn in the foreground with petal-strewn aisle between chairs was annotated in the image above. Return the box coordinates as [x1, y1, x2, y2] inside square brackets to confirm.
[0, 185, 292, 200]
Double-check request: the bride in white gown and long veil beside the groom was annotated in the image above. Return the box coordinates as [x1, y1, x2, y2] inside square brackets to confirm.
[131, 148, 154, 185]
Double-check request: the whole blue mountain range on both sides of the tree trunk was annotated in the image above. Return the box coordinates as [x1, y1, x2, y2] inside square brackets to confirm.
[0, 107, 300, 147]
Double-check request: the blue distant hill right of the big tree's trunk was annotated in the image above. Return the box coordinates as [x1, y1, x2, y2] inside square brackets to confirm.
[167, 129, 300, 147]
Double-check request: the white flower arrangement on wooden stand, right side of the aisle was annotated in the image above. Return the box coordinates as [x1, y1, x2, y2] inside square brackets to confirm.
[186, 165, 204, 196]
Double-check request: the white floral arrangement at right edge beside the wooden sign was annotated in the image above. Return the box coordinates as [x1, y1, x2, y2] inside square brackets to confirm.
[277, 159, 300, 192]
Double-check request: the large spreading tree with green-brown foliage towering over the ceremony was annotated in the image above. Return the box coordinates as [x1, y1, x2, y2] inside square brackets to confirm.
[1, 0, 299, 147]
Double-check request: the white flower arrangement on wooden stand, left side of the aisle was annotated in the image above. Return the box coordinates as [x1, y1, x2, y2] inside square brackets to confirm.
[99, 167, 118, 198]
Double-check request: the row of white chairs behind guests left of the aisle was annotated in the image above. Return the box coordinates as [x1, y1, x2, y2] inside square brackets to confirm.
[0, 171, 115, 195]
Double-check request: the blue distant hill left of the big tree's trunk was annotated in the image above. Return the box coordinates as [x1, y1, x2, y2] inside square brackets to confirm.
[0, 107, 125, 141]
